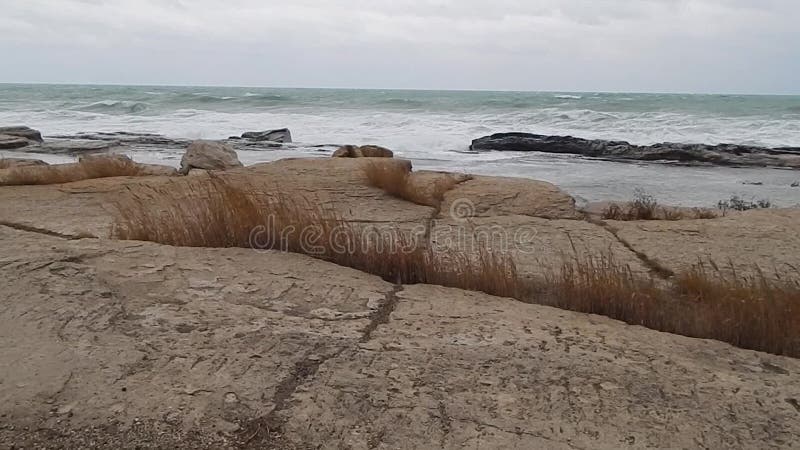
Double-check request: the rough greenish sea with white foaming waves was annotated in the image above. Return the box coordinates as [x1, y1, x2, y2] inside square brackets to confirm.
[0, 84, 800, 206]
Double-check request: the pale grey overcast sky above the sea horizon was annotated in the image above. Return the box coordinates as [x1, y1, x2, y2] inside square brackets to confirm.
[0, 0, 800, 94]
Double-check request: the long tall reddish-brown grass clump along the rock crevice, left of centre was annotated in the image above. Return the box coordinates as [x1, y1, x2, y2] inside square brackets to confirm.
[112, 176, 519, 297]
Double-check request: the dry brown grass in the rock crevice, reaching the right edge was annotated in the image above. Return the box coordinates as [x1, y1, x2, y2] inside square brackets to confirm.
[527, 256, 800, 357]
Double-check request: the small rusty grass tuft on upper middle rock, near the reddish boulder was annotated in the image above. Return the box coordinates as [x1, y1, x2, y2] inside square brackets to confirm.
[364, 162, 458, 208]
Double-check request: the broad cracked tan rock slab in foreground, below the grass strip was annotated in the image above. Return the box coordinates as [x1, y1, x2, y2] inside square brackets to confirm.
[0, 226, 800, 449]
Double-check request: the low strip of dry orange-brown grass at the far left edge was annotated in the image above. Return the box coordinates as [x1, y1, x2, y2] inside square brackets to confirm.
[2, 157, 142, 186]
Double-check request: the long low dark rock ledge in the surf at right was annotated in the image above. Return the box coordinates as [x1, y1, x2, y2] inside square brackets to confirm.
[470, 133, 800, 168]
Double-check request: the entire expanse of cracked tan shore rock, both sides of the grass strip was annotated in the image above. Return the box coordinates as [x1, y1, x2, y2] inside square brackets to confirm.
[0, 140, 800, 449]
